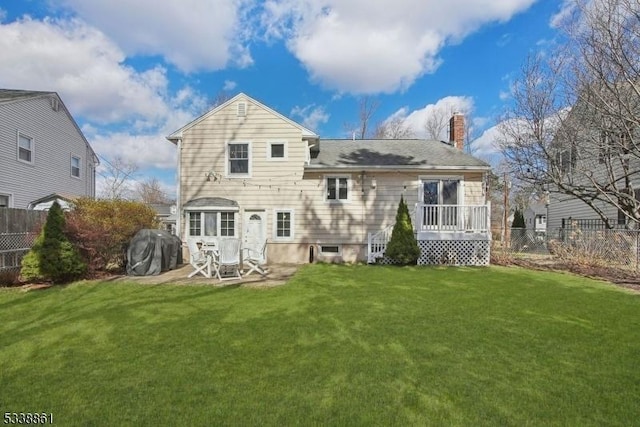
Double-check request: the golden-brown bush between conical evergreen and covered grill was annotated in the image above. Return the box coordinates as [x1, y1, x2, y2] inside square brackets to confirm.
[67, 198, 158, 274]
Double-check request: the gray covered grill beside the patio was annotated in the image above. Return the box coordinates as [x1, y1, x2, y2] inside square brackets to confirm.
[127, 228, 182, 276]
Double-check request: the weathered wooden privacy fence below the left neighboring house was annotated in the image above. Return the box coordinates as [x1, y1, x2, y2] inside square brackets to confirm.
[0, 208, 47, 272]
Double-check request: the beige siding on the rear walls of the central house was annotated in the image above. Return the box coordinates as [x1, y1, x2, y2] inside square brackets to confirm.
[180, 95, 484, 263]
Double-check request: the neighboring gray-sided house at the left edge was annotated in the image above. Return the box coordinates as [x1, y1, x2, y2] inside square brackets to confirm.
[0, 89, 98, 209]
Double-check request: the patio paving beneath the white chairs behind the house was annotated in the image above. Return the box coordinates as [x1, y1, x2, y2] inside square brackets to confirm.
[112, 264, 299, 287]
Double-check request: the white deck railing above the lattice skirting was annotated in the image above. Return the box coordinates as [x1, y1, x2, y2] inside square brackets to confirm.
[415, 203, 490, 233]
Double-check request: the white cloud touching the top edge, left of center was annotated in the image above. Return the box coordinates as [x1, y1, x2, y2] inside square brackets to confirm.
[57, 0, 252, 72]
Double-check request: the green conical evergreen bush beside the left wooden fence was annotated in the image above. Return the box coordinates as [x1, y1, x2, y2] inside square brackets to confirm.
[20, 202, 87, 283]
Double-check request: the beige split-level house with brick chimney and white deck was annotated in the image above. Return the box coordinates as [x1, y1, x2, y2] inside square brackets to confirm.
[167, 93, 490, 265]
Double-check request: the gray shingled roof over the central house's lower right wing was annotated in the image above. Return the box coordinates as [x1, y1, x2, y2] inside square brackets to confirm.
[307, 139, 490, 169]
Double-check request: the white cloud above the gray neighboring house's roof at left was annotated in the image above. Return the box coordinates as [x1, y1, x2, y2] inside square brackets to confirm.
[0, 17, 168, 123]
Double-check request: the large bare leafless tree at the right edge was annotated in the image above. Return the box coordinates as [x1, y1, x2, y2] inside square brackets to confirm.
[500, 0, 640, 227]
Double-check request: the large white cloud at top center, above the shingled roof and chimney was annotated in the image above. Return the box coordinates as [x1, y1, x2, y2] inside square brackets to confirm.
[261, 0, 535, 93]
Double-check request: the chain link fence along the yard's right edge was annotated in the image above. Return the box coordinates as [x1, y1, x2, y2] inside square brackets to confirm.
[491, 227, 640, 271]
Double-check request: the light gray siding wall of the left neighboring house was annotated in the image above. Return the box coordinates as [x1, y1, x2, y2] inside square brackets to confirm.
[0, 97, 95, 208]
